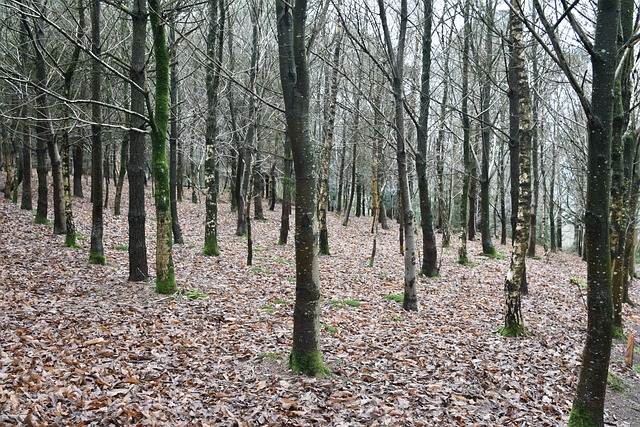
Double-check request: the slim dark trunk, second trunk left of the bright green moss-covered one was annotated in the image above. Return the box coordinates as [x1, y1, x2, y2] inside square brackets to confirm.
[89, 0, 105, 264]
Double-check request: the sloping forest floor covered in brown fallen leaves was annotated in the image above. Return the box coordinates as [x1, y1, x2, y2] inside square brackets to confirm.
[0, 186, 640, 426]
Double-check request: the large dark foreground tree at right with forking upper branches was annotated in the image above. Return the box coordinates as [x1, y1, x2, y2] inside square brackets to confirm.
[534, 0, 620, 426]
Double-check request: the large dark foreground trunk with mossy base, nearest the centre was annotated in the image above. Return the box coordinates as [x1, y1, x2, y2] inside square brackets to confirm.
[276, 0, 328, 376]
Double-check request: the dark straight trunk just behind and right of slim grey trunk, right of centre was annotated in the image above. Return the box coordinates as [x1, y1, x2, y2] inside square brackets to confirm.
[416, 0, 438, 277]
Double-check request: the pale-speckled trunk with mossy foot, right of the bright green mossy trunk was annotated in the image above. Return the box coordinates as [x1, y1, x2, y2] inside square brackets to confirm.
[202, 0, 225, 256]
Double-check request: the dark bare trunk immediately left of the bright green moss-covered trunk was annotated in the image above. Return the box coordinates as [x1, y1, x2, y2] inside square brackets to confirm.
[127, 0, 149, 282]
